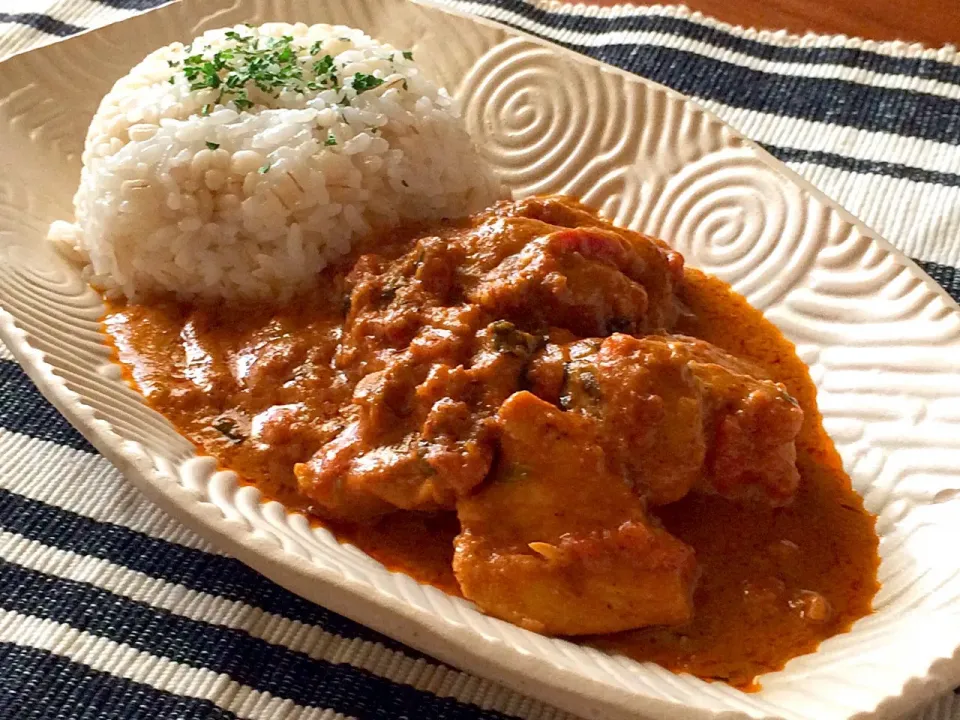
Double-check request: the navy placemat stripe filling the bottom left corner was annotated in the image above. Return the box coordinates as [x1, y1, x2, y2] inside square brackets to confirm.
[0, 643, 236, 720]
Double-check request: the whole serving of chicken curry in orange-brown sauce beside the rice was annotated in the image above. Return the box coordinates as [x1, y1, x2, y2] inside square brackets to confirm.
[105, 197, 877, 687]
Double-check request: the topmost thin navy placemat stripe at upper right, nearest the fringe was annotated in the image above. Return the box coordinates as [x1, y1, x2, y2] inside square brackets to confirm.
[480, 0, 960, 83]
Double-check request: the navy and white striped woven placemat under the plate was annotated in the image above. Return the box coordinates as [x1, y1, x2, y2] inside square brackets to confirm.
[0, 0, 960, 720]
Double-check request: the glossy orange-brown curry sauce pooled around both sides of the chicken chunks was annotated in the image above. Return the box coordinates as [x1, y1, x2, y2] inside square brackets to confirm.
[104, 198, 878, 690]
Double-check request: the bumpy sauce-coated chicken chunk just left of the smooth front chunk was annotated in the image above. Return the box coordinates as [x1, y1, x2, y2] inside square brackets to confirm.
[294, 321, 537, 520]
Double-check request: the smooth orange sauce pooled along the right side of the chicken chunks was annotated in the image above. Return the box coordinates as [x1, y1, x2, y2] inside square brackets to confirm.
[595, 269, 879, 689]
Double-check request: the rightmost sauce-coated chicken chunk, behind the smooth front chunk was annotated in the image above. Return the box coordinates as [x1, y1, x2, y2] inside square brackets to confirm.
[530, 335, 803, 505]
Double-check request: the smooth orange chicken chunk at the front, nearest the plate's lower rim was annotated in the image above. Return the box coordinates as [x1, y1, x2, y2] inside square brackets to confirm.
[454, 392, 697, 635]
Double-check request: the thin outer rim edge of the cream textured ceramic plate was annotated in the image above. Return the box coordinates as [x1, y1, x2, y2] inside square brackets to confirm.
[0, 0, 960, 720]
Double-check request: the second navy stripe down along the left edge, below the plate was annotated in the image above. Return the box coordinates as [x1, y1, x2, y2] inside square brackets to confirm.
[0, 488, 422, 657]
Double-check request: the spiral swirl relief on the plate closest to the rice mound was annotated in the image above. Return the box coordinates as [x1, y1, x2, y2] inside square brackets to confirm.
[458, 38, 732, 227]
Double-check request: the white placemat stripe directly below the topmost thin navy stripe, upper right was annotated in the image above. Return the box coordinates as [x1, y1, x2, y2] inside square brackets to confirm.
[436, 2, 960, 99]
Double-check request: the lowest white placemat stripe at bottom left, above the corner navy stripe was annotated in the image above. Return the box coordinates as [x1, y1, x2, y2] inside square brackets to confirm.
[0, 610, 354, 720]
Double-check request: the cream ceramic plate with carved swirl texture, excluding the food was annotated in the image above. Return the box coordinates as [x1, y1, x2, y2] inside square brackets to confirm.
[0, 0, 960, 720]
